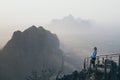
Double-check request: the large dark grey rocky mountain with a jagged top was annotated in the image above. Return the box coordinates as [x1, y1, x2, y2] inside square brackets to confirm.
[0, 26, 63, 80]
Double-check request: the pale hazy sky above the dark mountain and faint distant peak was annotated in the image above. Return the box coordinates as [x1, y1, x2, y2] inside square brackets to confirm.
[0, 0, 120, 47]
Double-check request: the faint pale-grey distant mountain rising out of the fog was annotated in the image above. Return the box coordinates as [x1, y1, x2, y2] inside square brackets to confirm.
[51, 15, 91, 28]
